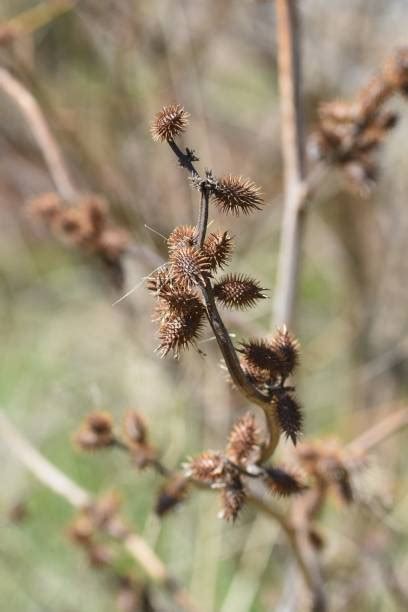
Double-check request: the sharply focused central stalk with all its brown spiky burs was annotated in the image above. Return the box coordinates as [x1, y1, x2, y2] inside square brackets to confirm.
[143, 104, 304, 520]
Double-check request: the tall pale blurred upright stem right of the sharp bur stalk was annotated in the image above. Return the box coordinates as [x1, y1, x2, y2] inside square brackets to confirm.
[274, 0, 307, 326]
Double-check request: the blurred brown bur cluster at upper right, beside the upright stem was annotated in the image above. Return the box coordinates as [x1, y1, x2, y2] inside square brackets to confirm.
[310, 47, 408, 196]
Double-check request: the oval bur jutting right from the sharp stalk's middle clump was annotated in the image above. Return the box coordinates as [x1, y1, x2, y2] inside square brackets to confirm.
[214, 274, 266, 309]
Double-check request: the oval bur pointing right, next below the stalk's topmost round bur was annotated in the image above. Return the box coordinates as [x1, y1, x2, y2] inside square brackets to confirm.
[212, 175, 263, 215]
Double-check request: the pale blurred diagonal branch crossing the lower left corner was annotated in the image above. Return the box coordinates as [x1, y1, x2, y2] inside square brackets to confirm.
[0, 413, 197, 612]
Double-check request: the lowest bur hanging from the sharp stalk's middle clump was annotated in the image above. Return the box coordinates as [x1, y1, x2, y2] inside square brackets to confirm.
[158, 300, 205, 357]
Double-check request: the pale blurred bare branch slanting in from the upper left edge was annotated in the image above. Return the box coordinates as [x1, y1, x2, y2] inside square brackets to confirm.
[0, 67, 77, 200]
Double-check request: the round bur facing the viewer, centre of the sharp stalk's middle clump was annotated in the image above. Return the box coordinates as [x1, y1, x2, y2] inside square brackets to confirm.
[170, 247, 211, 290]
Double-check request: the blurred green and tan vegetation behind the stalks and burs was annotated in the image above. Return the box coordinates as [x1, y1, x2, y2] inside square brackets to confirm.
[0, 0, 408, 612]
